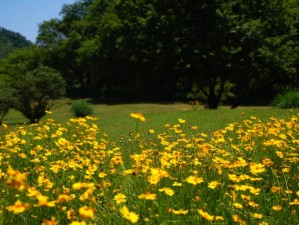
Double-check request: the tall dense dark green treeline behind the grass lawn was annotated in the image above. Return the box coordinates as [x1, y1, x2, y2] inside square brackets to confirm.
[0, 0, 299, 108]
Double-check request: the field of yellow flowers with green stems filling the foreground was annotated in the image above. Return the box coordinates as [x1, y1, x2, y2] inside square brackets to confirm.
[0, 113, 299, 225]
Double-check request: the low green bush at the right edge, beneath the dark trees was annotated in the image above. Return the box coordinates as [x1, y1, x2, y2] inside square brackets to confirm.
[273, 89, 299, 109]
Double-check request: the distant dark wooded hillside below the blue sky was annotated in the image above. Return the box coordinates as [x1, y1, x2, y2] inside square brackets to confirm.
[0, 27, 32, 58]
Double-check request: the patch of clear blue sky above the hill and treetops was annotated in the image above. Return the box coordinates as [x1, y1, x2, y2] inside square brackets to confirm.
[0, 0, 76, 42]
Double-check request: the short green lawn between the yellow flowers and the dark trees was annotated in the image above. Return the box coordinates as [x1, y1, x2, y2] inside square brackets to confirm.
[4, 99, 299, 139]
